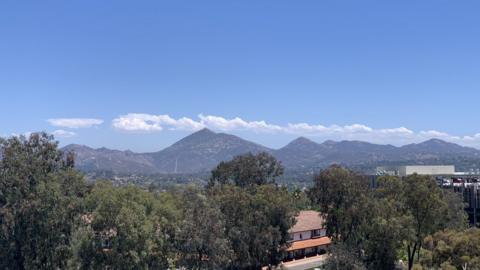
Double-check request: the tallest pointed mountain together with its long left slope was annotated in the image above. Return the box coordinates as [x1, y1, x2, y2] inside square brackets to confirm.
[63, 129, 273, 174]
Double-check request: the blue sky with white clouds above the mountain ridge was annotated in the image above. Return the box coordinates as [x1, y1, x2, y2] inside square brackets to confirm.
[0, 0, 480, 151]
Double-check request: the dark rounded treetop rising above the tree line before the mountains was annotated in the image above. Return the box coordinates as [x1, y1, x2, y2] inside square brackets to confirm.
[209, 152, 283, 187]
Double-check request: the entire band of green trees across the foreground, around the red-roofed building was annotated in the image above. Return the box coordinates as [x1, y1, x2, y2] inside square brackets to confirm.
[0, 133, 472, 270]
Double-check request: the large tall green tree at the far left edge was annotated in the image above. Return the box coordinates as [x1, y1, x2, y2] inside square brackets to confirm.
[0, 133, 88, 269]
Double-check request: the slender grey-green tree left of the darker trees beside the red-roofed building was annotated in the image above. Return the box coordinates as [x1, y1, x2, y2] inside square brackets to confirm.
[176, 186, 234, 269]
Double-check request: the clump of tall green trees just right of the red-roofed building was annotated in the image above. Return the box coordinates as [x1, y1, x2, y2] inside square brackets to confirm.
[309, 166, 466, 270]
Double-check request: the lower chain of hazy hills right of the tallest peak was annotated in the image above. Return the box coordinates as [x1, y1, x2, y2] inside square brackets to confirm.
[275, 138, 480, 172]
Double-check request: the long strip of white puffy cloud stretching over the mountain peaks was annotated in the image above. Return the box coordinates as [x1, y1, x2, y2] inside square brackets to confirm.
[112, 113, 480, 147]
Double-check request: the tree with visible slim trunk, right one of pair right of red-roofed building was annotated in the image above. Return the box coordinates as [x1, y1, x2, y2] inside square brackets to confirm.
[375, 174, 466, 269]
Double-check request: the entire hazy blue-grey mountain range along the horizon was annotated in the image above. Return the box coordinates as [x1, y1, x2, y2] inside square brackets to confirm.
[63, 129, 480, 174]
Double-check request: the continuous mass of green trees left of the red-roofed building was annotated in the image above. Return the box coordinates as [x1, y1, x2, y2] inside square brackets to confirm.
[0, 133, 300, 270]
